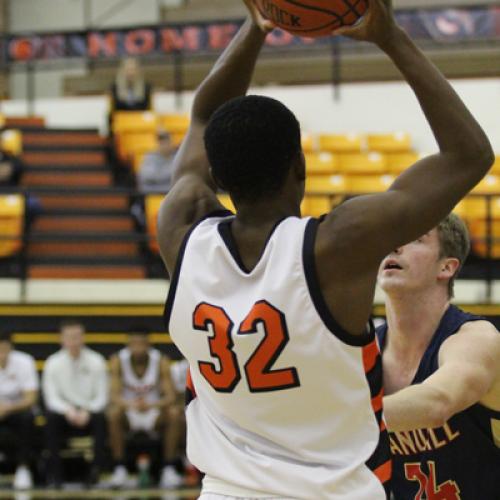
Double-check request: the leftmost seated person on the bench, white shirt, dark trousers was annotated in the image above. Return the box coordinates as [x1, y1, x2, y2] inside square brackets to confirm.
[0, 332, 38, 490]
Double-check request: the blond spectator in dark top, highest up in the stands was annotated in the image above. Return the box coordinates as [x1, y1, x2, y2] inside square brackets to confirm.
[111, 57, 151, 111]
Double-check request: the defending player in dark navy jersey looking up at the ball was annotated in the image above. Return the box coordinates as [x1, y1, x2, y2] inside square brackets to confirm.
[377, 215, 500, 500]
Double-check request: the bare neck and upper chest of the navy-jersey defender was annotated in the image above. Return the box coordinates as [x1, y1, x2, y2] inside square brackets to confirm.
[386, 288, 450, 358]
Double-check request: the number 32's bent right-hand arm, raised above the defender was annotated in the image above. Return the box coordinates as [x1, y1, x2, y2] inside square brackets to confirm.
[315, 0, 493, 334]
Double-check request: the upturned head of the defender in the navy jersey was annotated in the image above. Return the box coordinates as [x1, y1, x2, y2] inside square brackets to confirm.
[379, 214, 470, 298]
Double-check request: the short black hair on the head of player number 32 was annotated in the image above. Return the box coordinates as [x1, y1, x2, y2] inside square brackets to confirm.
[205, 96, 301, 201]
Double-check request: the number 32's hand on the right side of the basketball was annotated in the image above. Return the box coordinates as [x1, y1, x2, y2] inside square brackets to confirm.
[333, 0, 398, 45]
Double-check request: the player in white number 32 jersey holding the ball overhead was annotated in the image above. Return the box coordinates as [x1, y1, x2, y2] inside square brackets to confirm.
[158, 0, 493, 500]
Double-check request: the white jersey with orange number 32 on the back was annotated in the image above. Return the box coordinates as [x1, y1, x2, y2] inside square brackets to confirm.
[165, 213, 391, 500]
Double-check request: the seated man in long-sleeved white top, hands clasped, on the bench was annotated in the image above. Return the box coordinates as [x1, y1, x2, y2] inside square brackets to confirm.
[42, 320, 108, 488]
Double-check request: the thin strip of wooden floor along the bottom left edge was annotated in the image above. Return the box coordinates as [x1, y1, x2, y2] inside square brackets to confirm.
[0, 489, 199, 500]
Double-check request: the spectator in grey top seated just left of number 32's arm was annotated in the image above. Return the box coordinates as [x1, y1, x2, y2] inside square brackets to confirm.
[137, 130, 177, 193]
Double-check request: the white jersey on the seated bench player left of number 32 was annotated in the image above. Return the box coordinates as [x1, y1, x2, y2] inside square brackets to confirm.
[118, 347, 161, 403]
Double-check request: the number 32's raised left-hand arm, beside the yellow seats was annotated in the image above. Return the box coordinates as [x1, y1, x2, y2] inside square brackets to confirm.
[158, 0, 272, 273]
